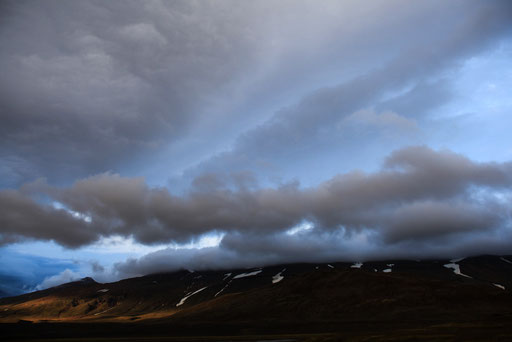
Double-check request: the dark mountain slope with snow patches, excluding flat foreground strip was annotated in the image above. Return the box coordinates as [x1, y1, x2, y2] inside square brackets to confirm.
[0, 256, 512, 340]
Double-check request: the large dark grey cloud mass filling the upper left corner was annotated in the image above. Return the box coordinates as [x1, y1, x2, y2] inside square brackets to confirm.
[0, 1, 290, 184]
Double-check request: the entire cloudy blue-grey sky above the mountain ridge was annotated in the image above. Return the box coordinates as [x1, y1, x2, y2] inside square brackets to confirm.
[0, 0, 512, 295]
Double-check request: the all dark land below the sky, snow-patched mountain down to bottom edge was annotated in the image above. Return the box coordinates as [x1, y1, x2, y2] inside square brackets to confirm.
[0, 256, 512, 342]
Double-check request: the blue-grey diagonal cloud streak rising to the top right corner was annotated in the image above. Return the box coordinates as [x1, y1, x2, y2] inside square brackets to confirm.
[178, 2, 512, 184]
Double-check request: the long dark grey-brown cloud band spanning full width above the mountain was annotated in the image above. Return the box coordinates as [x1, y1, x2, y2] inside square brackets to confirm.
[0, 147, 512, 247]
